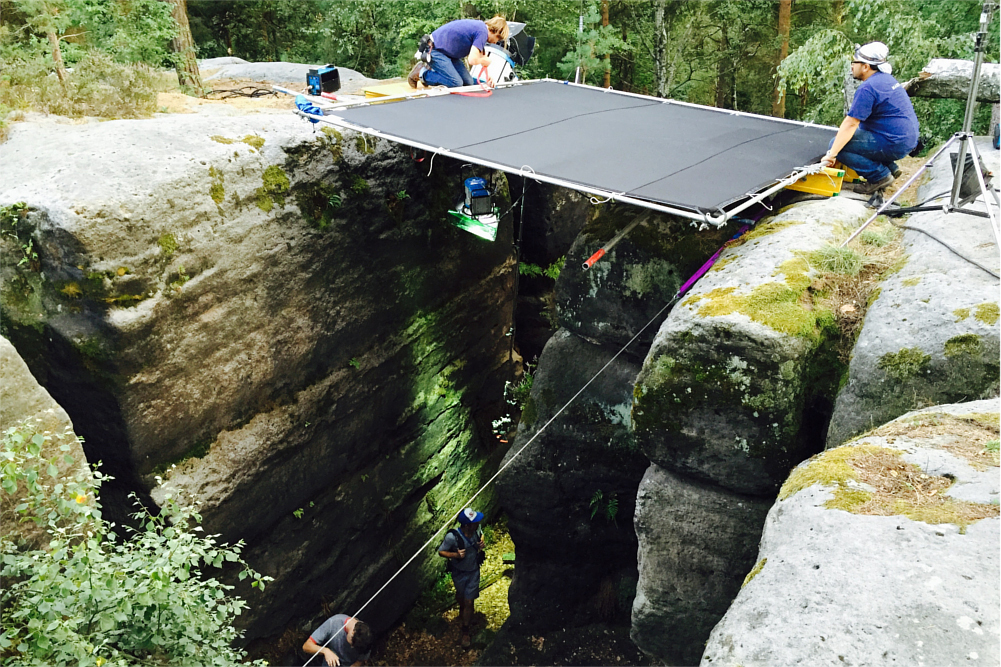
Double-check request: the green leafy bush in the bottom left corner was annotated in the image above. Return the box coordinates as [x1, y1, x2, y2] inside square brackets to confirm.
[0, 423, 270, 667]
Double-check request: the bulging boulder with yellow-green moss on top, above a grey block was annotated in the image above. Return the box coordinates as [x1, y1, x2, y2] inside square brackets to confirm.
[633, 199, 867, 495]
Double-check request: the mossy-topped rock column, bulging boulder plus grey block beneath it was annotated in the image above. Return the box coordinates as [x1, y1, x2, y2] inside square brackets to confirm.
[633, 199, 866, 664]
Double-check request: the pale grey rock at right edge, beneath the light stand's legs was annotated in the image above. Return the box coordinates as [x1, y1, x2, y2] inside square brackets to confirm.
[827, 140, 1001, 447]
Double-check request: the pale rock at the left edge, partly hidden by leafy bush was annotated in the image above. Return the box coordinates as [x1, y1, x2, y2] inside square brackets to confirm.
[0, 337, 90, 549]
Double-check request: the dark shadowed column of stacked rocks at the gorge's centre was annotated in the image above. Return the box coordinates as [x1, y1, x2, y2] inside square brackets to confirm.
[494, 206, 733, 640]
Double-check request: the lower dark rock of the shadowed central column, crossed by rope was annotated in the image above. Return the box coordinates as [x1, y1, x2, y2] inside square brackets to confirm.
[497, 329, 647, 632]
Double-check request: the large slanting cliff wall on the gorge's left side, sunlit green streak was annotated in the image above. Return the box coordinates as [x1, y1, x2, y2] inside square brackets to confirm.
[0, 112, 514, 637]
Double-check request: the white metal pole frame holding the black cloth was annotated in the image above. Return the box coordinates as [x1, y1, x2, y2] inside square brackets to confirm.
[295, 79, 823, 229]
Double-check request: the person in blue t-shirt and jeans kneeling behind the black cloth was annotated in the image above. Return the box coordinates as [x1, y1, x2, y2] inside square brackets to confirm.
[406, 16, 511, 88]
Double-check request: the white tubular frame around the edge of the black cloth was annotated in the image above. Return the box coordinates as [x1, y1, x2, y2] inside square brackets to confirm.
[295, 79, 837, 229]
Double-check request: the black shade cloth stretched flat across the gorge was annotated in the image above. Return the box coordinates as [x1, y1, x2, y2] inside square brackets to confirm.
[330, 81, 836, 212]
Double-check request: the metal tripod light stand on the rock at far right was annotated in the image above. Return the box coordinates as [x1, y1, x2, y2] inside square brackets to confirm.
[840, 2, 1001, 248]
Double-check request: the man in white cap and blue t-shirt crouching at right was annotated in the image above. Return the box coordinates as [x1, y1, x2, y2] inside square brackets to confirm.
[821, 42, 918, 194]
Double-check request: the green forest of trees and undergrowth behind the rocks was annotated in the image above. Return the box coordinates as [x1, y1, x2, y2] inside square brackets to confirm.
[0, 0, 999, 147]
